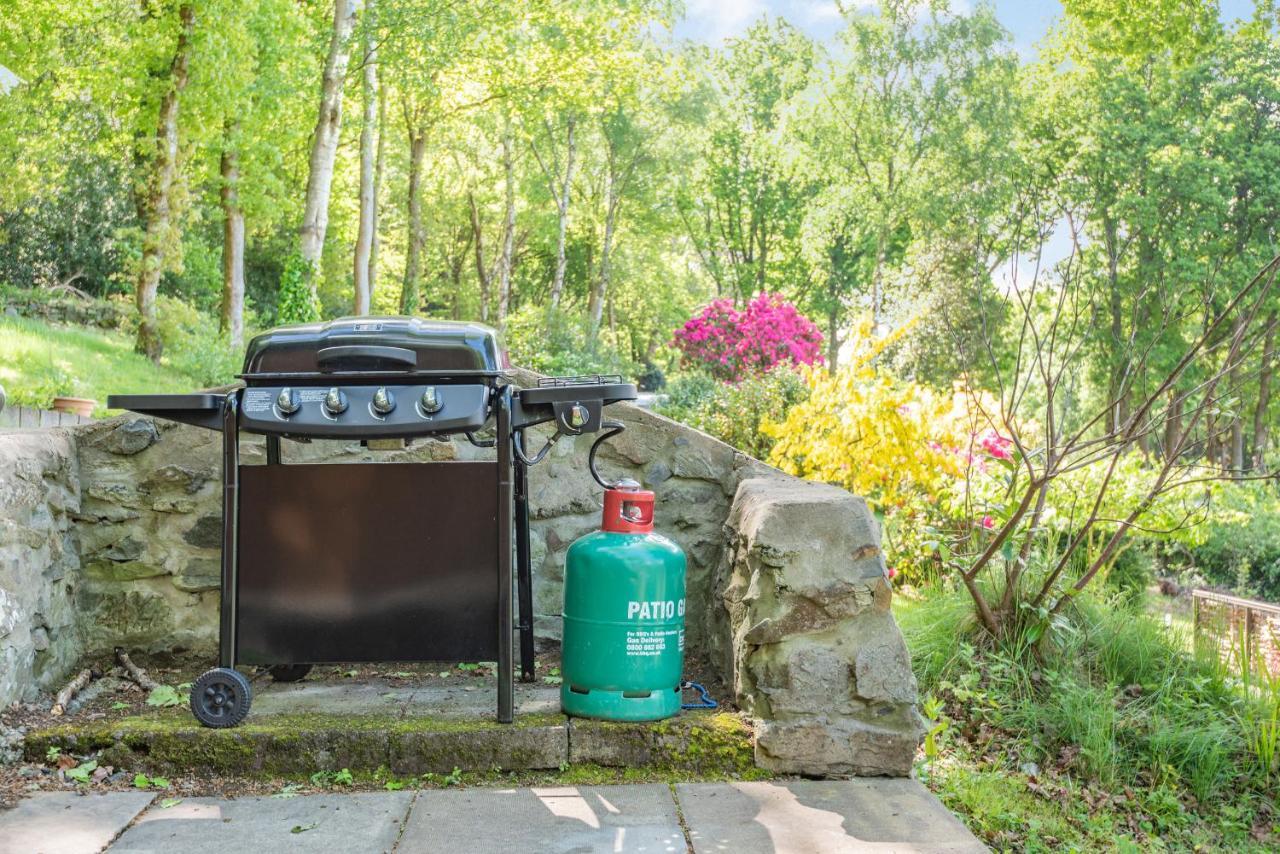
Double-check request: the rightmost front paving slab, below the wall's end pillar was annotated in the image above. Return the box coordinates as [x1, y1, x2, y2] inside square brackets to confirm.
[676, 778, 987, 854]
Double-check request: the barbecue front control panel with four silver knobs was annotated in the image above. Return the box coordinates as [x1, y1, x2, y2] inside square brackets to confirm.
[239, 384, 490, 439]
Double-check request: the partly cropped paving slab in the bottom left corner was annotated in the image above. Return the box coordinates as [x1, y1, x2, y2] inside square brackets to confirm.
[0, 791, 152, 854]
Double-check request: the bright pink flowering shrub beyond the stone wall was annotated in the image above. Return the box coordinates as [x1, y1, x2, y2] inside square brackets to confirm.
[672, 293, 822, 383]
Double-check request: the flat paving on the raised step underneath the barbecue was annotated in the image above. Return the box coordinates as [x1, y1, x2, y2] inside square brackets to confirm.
[250, 677, 559, 720]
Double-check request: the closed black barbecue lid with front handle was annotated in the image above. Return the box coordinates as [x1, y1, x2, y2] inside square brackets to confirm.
[242, 318, 508, 379]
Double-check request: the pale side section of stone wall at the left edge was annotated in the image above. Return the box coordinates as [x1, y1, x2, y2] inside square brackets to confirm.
[0, 430, 82, 704]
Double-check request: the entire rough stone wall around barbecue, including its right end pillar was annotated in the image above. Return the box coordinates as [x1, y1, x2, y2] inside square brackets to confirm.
[0, 378, 919, 775]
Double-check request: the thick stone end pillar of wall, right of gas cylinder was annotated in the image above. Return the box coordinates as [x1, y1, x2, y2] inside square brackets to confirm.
[714, 476, 923, 775]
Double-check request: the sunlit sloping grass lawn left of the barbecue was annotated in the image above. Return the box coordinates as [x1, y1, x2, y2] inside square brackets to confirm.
[0, 316, 198, 416]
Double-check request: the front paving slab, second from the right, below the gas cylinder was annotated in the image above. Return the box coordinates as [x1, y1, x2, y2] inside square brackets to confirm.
[396, 785, 687, 854]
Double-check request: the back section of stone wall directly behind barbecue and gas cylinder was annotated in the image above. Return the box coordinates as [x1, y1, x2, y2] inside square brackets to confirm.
[77, 396, 762, 653]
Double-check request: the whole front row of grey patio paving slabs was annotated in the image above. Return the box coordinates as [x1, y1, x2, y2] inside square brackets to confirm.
[0, 778, 986, 854]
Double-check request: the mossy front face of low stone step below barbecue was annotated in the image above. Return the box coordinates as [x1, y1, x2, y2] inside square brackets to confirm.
[24, 709, 754, 777]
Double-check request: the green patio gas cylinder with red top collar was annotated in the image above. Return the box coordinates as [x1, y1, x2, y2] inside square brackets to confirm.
[561, 480, 685, 721]
